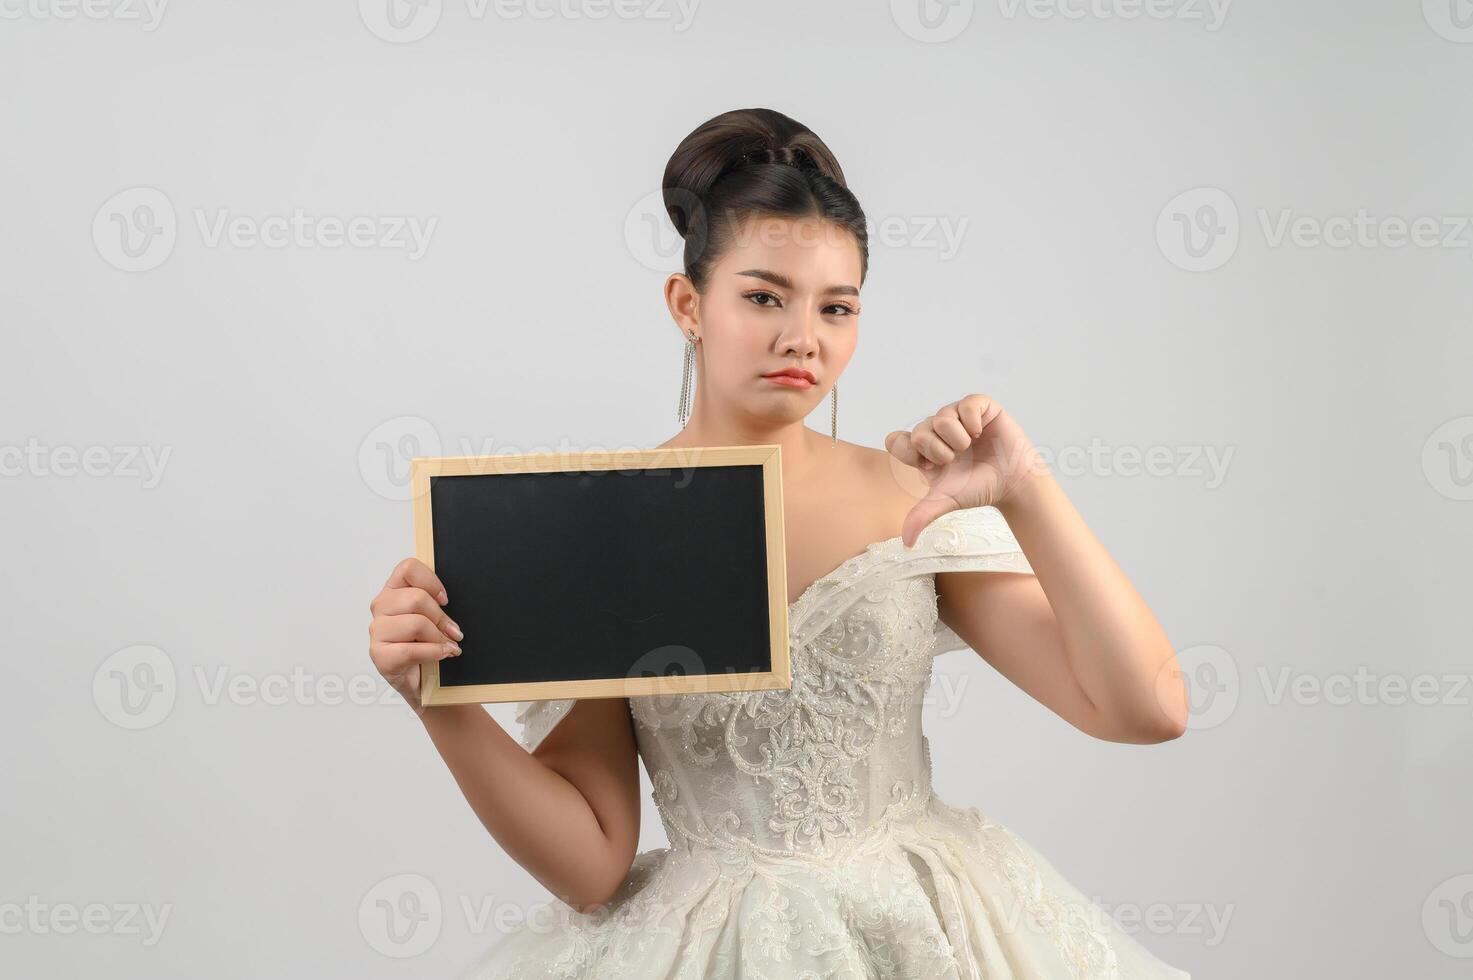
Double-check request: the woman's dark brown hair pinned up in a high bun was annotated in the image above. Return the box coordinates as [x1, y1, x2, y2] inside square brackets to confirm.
[660, 109, 869, 290]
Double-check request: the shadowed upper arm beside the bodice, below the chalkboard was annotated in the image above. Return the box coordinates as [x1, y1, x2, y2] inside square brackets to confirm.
[532, 697, 639, 890]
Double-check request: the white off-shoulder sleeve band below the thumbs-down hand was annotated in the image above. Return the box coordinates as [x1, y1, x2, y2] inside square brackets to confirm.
[791, 507, 1033, 654]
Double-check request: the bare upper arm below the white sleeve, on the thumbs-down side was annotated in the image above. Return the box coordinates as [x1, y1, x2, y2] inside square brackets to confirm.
[935, 572, 1100, 735]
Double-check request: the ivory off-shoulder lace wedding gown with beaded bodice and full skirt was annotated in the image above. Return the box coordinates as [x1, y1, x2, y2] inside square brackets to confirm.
[461, 507, 1189, 980]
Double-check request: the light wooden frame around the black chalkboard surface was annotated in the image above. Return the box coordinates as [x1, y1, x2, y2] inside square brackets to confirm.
[409, 445, 792, 707]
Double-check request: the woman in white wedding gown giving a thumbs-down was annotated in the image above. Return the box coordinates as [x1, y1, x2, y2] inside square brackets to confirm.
[370, 109, 1187, 980]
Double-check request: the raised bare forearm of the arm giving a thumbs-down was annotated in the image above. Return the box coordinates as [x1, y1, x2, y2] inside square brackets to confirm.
[997, 469, 1187, 734]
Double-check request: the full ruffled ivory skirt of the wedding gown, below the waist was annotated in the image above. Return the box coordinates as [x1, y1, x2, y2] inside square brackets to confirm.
[461, 796, 1190, 980]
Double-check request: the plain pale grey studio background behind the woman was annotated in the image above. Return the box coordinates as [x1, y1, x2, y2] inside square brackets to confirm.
[0, 0, 1473, 980]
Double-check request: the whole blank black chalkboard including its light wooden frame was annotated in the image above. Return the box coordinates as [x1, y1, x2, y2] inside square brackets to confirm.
[411, 445, 791, 706]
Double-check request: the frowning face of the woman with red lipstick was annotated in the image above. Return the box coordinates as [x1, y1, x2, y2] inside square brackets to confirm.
[667, 218, 860, 424]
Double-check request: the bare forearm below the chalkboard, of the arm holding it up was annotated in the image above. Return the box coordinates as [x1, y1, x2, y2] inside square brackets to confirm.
[420, 704, 626, 911]
